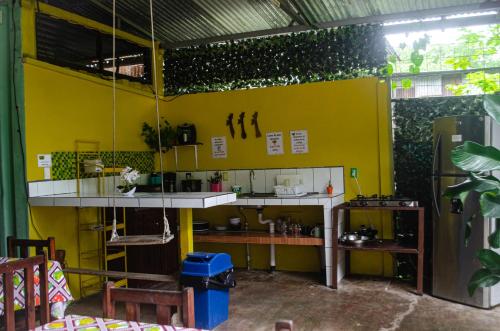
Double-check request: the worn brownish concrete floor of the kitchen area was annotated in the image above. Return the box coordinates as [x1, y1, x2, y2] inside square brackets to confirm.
[67, 271, 500, 331]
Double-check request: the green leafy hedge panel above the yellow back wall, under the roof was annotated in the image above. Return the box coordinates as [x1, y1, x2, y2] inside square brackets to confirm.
[164, 25, 387, 95]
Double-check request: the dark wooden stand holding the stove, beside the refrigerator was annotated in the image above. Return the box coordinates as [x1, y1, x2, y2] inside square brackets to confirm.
[332, 203, 425, 295]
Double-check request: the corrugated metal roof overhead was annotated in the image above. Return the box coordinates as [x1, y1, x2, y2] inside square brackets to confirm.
[45, 0, 500, 45]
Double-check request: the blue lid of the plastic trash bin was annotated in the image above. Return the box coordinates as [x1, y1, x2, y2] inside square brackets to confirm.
[181, 252, 233, 277]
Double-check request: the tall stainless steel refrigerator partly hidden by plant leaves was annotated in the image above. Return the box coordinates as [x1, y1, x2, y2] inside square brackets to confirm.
[432, 116, 500, 308]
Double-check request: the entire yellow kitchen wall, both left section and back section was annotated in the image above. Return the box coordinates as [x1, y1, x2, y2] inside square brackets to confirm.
[23, 1, 392, 284]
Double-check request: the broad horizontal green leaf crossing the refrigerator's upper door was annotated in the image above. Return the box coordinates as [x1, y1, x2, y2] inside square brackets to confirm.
[451, 141, 500, 172]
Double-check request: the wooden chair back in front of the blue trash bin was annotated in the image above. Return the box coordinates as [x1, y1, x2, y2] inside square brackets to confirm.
[103, 282, 194, 328]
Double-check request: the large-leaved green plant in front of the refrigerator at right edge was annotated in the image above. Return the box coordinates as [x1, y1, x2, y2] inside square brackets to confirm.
[444, 94, 500, 296]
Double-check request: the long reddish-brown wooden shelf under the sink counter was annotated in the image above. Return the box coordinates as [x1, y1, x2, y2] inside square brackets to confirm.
[193, 231, 325, 246]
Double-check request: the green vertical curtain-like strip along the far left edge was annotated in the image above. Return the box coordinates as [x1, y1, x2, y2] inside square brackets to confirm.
[0, 0, 28, 256]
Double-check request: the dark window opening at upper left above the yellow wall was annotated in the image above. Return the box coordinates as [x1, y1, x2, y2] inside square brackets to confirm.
[36, 13, 151, 84]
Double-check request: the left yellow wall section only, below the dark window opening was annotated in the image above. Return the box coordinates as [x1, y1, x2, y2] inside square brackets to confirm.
[24, 61, 155, 297]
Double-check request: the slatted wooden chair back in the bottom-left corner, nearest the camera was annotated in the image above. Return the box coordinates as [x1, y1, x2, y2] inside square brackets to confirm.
[0, 254, 50, 331]
